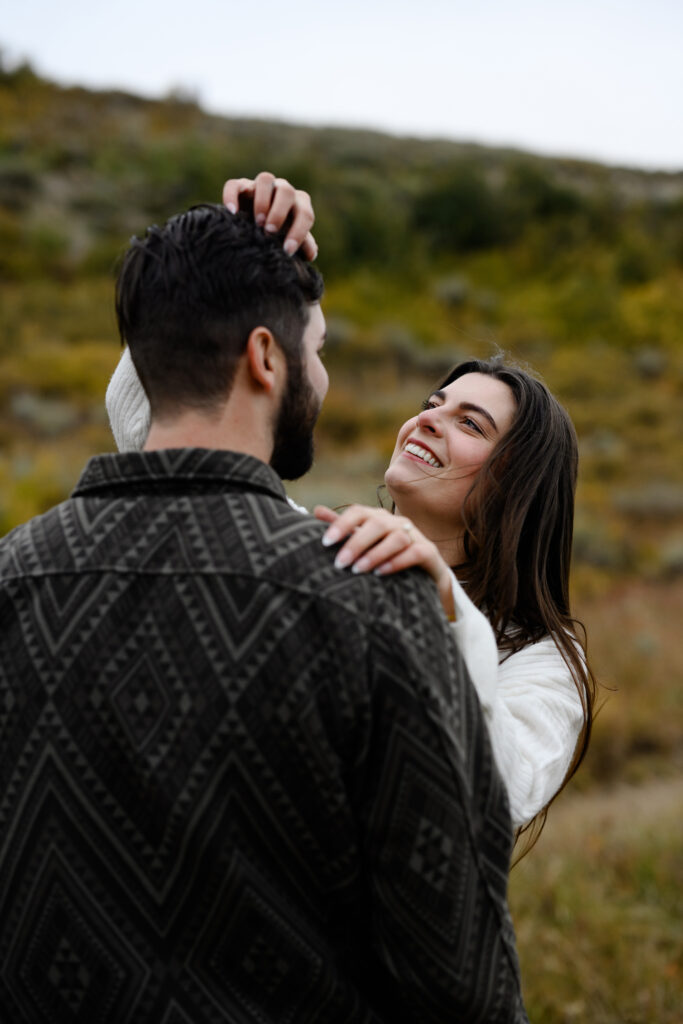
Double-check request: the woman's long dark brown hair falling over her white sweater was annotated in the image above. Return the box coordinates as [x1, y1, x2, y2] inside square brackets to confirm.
[439, 356, 596, 859]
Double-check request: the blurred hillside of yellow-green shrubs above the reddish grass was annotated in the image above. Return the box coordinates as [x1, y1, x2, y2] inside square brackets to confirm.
[0, 49, 683, 745]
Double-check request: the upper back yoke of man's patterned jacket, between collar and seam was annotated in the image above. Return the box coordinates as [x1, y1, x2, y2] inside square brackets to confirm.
[0, 489, 438, 630]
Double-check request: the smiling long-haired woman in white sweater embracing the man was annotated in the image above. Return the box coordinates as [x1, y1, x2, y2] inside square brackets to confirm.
[106, 174, 595, 830]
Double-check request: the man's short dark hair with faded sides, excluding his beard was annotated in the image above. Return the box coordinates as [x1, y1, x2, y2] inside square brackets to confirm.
[116, 204, 323, 416]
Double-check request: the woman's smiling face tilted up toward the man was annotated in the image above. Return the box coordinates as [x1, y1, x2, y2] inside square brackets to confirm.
[384, 373, 516, 543]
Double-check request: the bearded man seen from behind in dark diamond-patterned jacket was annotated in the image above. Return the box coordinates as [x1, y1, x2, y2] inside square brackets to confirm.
[0, 195, 526, 1024]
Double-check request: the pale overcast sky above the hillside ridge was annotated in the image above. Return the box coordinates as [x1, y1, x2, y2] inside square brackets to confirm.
[5, 0, 683, 170]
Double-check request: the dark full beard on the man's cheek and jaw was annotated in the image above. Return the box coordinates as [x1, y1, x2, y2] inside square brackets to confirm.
[270, 359, 321, 480]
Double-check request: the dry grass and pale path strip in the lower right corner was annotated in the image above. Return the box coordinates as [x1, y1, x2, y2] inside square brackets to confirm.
[510, 779, 683, 1024]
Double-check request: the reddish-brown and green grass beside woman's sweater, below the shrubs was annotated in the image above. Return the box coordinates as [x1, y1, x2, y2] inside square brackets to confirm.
[510, 579, 683, 1024]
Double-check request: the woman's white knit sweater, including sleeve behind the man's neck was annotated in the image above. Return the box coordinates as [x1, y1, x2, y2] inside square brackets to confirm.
[105, 348, 584, 828]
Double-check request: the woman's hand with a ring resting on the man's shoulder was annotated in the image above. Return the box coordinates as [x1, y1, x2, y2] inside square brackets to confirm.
[313, 505, 456, 617]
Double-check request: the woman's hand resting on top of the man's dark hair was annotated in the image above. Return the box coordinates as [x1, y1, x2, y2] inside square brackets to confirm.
[223, 171, 317, 260]
